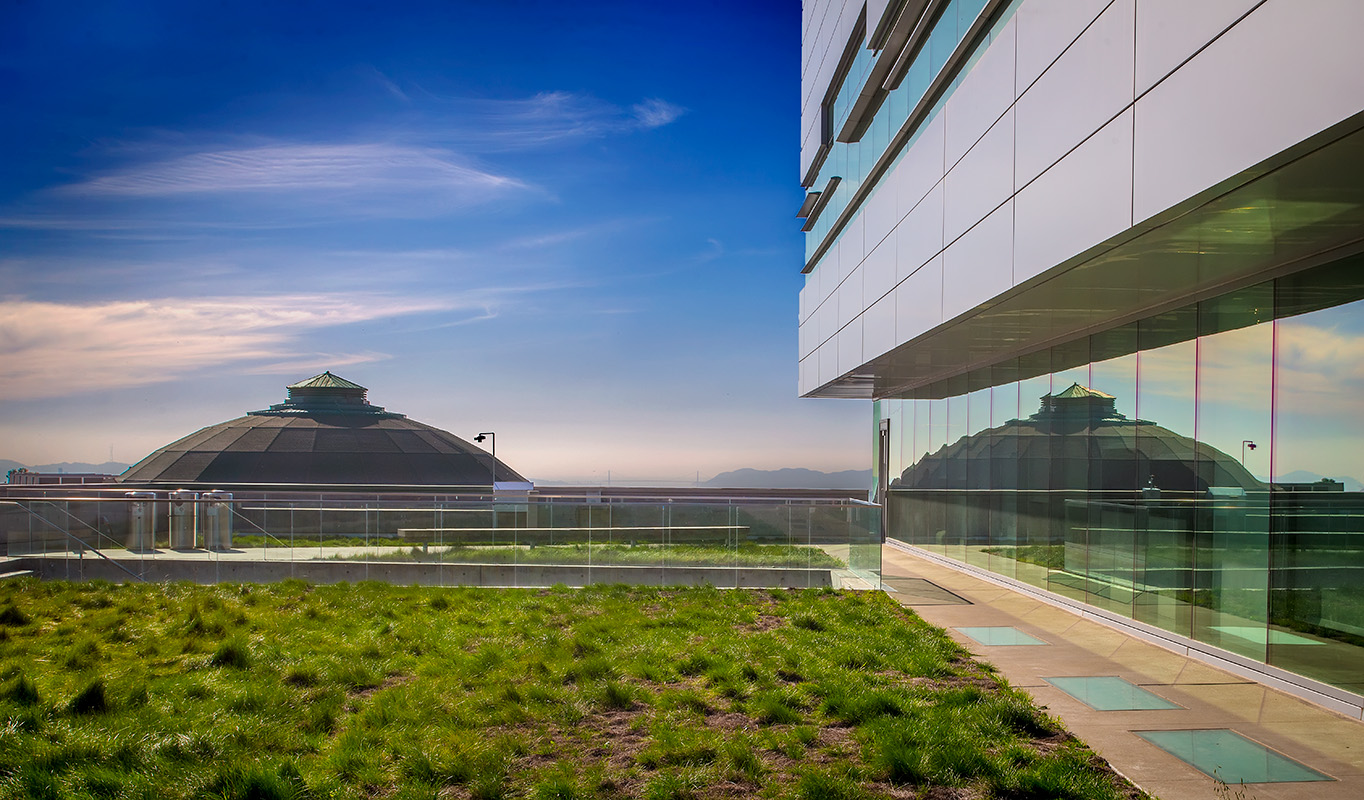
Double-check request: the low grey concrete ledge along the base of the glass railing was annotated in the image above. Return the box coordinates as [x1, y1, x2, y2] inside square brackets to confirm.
[18, 556, 833, 589]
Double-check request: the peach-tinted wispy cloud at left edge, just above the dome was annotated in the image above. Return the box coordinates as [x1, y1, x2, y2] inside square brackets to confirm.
[0, 292, 490, 401]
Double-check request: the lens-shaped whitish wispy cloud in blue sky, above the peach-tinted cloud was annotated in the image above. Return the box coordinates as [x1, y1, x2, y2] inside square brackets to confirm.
[61, 143, 525, 196]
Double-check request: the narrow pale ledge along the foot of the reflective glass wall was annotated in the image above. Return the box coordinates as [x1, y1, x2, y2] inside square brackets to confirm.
[885, 538, 1364, 720]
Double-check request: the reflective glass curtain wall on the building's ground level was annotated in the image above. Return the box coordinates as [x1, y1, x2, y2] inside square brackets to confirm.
[877, 258, 1364, 694]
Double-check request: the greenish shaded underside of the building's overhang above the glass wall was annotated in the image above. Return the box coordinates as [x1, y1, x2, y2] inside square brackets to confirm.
[805, 114, 1364, 399]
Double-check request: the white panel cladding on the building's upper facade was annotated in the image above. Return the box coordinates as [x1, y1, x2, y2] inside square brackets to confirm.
[799, 0, 1364, 391]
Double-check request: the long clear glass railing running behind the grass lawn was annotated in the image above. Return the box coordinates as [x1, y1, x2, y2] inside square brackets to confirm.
[0, 492, 881, 589]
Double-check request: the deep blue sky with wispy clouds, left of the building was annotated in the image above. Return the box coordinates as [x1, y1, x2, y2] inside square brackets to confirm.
[0, 0, 870, 482]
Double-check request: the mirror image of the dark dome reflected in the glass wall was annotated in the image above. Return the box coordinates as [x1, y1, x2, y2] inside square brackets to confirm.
[892, 383, 1267, 492]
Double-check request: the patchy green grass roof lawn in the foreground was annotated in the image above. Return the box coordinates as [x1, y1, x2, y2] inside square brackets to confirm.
[0, 581, 1138, 800]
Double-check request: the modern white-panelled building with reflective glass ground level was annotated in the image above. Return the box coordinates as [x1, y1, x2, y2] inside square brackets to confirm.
[799, 0, 1364, 717]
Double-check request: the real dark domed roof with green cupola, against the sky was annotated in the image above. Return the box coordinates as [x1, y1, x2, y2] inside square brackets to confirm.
[119, 372, 525, 487]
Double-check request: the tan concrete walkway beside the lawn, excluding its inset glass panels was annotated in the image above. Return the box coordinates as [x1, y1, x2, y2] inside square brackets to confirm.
[883, 547, 1364, 800]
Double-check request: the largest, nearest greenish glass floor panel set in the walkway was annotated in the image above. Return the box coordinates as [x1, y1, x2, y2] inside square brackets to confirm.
[1132, 729, 1335, 786]
